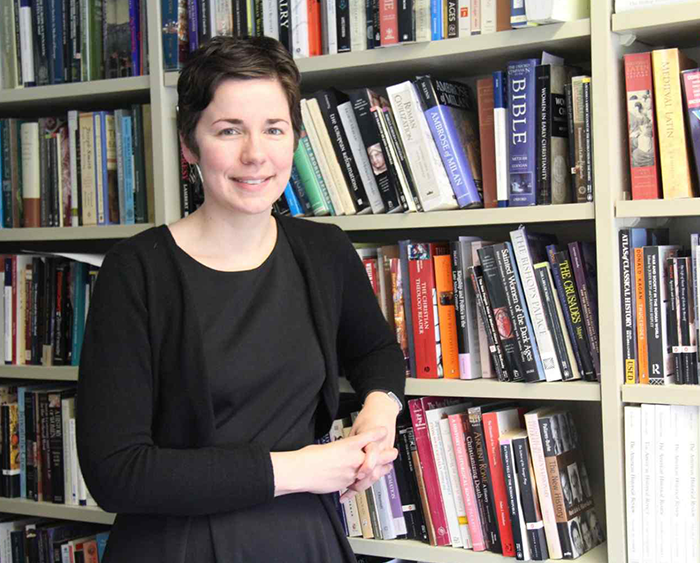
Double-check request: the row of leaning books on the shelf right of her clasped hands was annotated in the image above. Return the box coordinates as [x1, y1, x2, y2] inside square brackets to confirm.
[330, 397, 604, 561]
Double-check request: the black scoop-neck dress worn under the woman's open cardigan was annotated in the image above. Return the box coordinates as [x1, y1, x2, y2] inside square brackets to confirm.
[173, 226, 349, 563]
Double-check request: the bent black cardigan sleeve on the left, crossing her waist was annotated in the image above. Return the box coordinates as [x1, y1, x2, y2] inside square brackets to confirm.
[77, 252, 274, 516]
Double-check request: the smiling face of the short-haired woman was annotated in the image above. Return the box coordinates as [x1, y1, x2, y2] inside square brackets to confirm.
[183, 79, 294, 215]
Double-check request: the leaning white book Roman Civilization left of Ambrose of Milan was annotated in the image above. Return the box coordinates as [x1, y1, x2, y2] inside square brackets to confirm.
[386, 81, 459, 211]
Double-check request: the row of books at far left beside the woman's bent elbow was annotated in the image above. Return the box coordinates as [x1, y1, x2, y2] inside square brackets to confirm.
[0, 382, 96, 506]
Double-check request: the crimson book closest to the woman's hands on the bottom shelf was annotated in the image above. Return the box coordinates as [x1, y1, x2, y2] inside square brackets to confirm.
[408, 397, 458, 545]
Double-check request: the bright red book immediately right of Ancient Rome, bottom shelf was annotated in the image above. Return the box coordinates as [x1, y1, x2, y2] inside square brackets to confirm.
[482, 407, 521, 557]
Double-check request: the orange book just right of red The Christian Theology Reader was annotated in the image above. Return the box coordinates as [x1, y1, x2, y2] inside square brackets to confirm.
[433, 254, 459, 379]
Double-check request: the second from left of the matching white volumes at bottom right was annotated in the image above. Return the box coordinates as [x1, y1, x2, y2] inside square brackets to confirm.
[642, 404, 658, 563]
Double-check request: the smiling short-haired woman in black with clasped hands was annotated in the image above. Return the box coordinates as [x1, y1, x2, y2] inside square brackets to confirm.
[77, 38, 404, 563]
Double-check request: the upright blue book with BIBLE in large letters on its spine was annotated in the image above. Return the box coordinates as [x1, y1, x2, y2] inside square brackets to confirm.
[508, 59, 540, 207]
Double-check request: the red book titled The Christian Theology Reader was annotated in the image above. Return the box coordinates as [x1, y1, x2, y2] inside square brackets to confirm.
[408, 242, 450, 379]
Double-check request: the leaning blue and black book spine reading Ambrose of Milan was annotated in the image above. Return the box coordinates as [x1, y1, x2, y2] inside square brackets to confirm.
[416, 77, 483, 208]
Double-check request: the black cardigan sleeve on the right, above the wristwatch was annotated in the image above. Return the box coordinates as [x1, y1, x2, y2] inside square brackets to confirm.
[337, 227, 406, 408]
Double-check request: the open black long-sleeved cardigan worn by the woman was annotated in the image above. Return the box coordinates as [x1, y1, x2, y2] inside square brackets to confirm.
[77, 218, 405, 561]
